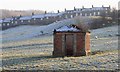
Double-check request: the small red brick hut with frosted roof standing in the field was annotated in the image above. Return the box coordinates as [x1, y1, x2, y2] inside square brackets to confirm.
[53, 25, 90, 56]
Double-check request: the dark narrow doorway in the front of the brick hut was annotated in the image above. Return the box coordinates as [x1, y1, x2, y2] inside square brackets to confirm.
[65, 34, 74, 56]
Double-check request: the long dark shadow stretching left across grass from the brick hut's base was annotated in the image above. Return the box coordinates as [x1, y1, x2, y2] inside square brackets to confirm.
[2, 55, 57, 67]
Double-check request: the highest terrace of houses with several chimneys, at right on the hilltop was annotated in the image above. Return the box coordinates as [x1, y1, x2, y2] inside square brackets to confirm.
[65, 5, 110, 16]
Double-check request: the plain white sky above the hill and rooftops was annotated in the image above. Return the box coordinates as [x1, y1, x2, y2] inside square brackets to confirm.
[0, 0, 119, 12]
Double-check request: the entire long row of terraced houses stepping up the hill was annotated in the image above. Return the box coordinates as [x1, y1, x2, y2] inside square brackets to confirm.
[2, 5, 111, 29]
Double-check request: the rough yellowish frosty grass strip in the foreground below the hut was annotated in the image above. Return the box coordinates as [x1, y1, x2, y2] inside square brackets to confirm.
[3, 52, 118, 70]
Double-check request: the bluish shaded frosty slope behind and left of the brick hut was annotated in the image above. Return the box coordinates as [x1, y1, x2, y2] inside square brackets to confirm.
[0, 19, 75, 43]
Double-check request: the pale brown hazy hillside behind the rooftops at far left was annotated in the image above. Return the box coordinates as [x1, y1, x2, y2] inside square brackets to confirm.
[0, 9, 44, 19]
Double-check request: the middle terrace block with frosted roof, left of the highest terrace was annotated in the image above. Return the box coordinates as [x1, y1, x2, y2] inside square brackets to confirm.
[32, 12, 64, 25]
